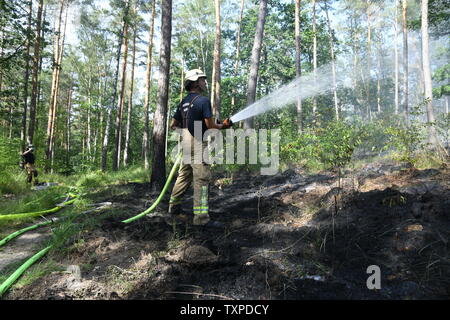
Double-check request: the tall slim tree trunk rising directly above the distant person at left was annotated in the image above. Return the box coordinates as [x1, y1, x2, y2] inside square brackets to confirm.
[27, 0, 44, 143]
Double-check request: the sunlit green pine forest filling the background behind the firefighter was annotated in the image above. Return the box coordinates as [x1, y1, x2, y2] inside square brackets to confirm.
[0, 0, 450, 180]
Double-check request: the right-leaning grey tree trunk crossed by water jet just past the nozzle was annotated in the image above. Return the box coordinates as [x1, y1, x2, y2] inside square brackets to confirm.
[244, 0, 267, 129]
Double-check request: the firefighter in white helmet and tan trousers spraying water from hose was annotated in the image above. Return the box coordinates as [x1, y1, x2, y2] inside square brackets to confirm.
[169, 69, 231, 227]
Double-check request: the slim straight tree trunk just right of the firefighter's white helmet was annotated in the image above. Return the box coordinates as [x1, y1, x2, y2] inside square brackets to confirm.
[211, 0, 221, 119]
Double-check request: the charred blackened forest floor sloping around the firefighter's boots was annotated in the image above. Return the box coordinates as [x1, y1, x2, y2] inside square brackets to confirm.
[3, 163, 450, 300]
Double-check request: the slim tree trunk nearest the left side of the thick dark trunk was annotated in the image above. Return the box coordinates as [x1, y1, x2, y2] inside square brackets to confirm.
[142, 0, 156, 169]
